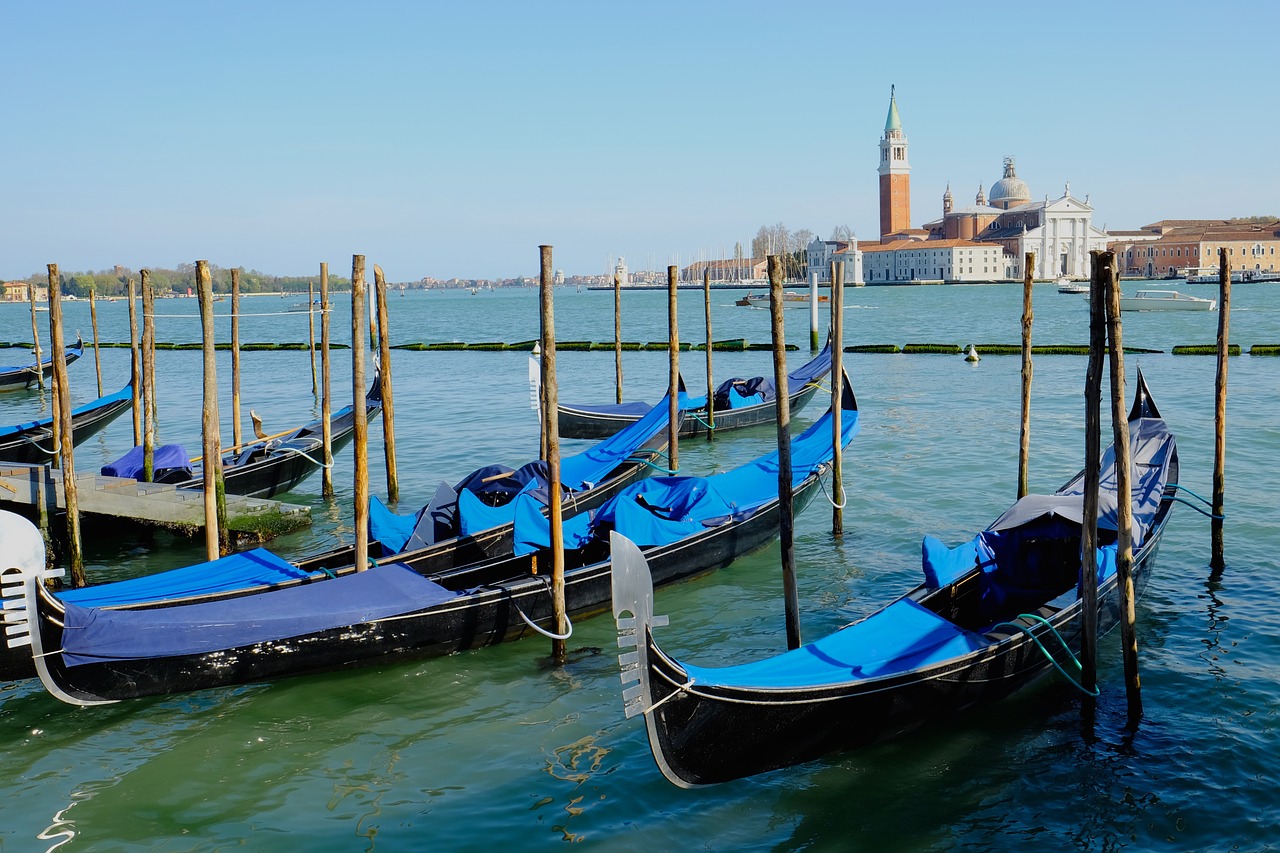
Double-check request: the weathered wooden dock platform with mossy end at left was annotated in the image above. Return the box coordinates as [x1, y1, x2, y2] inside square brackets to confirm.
[0, 462, 311, 542]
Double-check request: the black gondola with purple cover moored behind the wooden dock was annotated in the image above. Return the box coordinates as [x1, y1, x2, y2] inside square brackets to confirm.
[101, 375, 383, 498]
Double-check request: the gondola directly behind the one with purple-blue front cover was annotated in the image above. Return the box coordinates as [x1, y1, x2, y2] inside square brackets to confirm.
[0, 384, 667, 680]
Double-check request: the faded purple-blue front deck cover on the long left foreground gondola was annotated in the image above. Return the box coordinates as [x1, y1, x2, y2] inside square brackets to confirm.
[63, 564, 457, 666]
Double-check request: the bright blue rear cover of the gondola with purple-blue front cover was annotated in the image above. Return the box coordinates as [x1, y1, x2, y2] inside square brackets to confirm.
[515, 397, 859, 555]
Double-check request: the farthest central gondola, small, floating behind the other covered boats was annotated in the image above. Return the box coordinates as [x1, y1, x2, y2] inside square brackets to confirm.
[559, 339, 831, 438]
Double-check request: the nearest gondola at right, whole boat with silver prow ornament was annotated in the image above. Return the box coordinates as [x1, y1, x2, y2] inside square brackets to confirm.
[613, 373, 1178, 788]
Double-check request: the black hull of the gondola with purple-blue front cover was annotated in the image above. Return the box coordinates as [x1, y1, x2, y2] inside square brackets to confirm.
[37, 468, 818, 702]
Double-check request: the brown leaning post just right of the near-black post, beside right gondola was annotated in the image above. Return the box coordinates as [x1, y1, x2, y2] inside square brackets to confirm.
[1098, 252, 1142, 724]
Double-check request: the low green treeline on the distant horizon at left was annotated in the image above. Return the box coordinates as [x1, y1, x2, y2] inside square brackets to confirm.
[16, 264, 351, 298]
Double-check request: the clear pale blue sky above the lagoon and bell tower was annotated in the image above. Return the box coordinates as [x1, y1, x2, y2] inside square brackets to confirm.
[0, 0, 1280, 280]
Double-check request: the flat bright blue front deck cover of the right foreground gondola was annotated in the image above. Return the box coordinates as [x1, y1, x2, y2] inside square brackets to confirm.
[685, 598, 991, 689]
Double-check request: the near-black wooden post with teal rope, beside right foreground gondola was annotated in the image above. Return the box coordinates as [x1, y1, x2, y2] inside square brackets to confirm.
[1080, 251, 1106, 692]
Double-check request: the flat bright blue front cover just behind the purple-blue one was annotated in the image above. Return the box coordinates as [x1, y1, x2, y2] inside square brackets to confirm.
[58, 548, 317, 607]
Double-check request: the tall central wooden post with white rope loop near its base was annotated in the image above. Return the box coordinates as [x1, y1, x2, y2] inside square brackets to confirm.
[538, 246, 568, 663]
